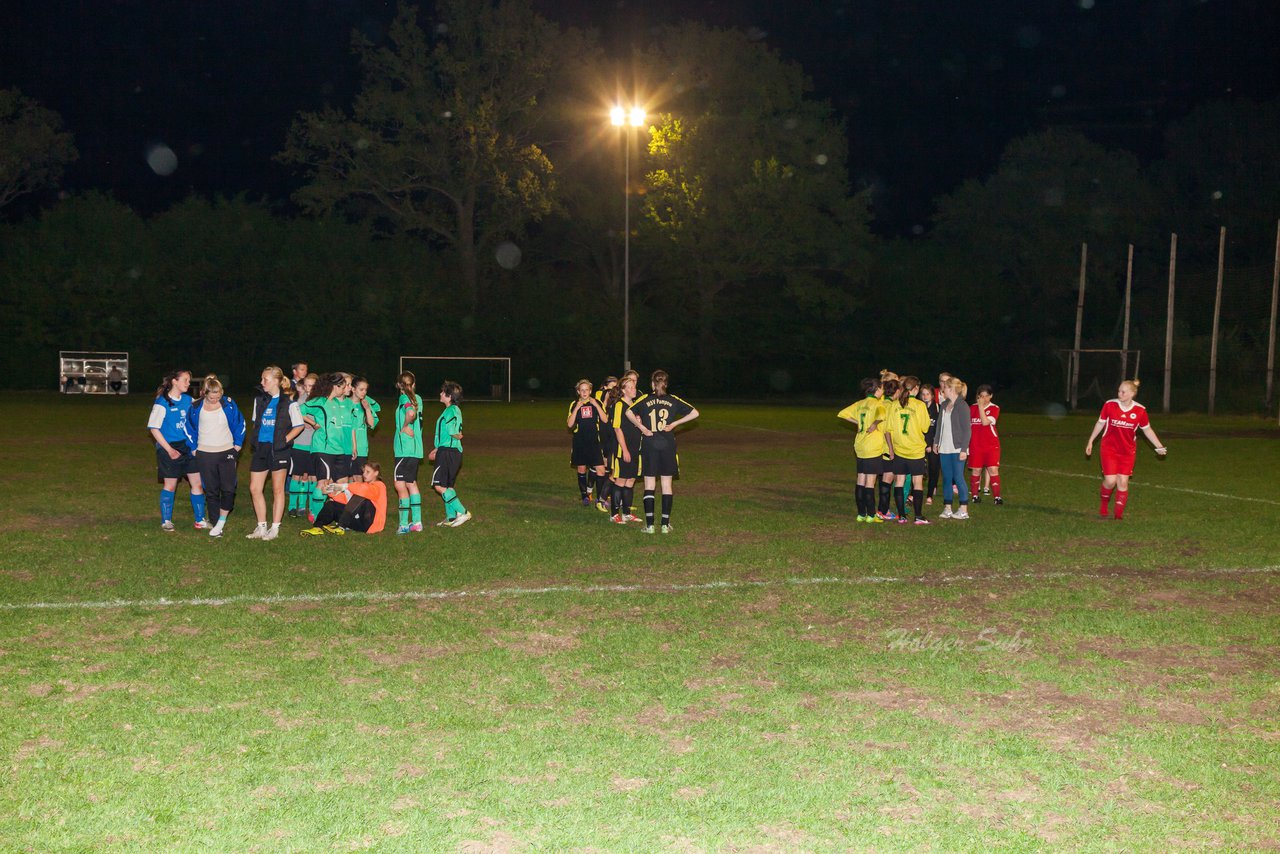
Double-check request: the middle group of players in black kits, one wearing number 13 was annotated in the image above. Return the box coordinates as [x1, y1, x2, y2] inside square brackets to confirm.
[564, 370, 698, 534]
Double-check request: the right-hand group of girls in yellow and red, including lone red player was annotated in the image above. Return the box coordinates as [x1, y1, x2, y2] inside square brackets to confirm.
[837, 371, 1166, 525]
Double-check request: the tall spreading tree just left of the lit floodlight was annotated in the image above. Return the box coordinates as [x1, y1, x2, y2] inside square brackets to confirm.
[279, 0, 564, 305]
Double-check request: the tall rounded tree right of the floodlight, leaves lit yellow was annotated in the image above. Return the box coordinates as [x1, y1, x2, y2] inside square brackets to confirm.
[632, 23, 869, 383]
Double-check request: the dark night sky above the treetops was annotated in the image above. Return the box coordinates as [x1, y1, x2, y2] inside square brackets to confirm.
[0, 0, 1280, 233]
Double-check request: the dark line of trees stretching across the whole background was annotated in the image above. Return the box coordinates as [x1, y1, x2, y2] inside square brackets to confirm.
[0, 0, 1280, 406]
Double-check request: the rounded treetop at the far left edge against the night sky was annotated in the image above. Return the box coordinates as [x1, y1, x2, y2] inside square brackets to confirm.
[0, 88, 78, 209]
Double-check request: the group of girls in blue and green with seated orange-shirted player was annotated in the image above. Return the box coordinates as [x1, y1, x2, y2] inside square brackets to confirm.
[147, 362, 471, 540]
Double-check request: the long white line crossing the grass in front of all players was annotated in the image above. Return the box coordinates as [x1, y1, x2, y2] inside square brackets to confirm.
[0, 565, 1280, 611]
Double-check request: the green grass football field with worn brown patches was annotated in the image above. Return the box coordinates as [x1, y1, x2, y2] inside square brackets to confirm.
[0, 394, 1280, 851]
